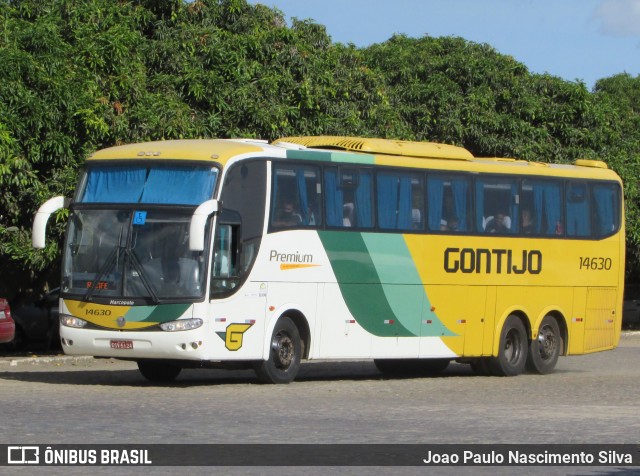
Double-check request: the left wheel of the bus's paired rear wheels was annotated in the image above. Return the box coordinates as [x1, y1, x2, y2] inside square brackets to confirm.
[488, 314, 529, 377]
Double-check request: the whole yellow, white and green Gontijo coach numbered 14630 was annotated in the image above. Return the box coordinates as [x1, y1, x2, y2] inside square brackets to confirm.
[33, 136, 625, 383]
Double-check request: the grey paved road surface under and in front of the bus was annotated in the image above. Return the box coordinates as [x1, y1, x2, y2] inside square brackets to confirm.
[0, 332, 640, 476]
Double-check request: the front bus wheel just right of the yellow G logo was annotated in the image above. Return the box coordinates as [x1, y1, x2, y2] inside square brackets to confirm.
[255, 317, 302, 383]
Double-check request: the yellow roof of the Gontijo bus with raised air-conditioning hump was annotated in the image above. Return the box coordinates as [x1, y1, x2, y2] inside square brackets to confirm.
[87, 136, 619, 180]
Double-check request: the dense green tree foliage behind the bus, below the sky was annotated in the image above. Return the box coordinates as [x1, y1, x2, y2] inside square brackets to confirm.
[0, 0, 640, 296]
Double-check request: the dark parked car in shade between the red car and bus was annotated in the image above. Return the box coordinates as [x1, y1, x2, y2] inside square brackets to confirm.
[11, 288, 60, 350]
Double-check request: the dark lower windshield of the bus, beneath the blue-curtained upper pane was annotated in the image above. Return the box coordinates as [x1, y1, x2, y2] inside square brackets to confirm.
[62, 208, 206, 302]
